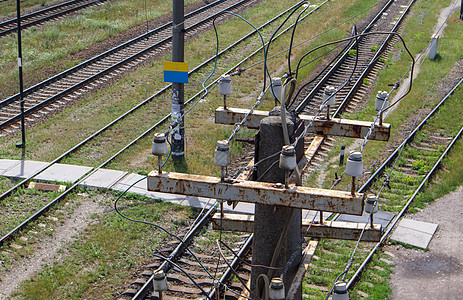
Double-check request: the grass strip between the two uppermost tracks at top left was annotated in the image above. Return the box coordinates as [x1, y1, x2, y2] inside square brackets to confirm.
[0, 0, 198, 98]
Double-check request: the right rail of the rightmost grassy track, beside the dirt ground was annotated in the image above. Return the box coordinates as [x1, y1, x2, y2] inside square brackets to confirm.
[347, 112, 463, 289]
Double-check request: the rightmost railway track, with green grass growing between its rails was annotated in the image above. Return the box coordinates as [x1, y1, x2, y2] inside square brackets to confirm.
[320, 79, 463, 294]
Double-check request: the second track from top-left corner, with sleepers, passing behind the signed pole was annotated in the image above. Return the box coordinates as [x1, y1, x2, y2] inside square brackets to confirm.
[0, 0, 255, 135]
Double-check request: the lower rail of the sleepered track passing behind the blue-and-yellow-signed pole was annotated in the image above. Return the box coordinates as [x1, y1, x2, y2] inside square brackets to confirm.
[0, 0, 250, 130]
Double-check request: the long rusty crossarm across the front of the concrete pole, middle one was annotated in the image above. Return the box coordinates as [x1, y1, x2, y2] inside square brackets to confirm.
[148, 171, 363, 215]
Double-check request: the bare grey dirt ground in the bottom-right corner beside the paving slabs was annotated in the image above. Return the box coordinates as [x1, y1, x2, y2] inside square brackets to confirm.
[384, 187, 463, 300]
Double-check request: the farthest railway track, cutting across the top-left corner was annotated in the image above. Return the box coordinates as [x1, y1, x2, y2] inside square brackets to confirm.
[0, 0, 106, 38]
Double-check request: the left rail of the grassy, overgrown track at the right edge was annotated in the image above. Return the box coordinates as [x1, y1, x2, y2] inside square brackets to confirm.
[358, 78, 463, 193]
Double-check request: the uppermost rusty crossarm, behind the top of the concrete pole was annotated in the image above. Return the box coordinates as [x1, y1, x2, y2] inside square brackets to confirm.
[215, 107, 391, 141]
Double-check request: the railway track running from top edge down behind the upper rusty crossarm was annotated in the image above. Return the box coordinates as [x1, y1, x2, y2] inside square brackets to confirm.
[290, 0, 414, 186]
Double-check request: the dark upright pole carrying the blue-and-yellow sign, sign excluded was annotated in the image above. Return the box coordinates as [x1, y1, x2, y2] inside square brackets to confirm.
[172, 0, 185, 159]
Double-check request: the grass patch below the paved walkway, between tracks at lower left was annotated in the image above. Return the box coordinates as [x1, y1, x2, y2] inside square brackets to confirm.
[15, 194, 191, 299]
